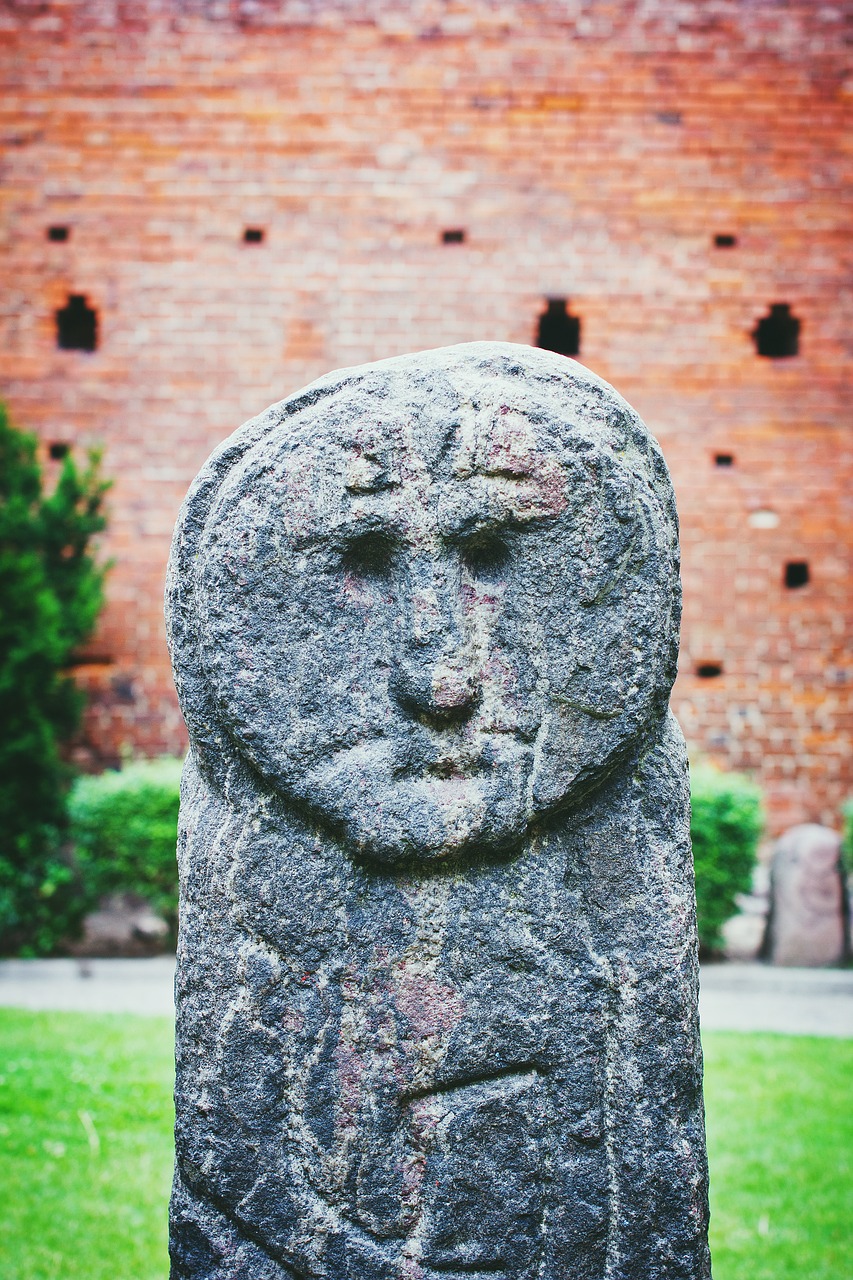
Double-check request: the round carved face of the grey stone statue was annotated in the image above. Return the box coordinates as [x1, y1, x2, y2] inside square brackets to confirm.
[188, 357, 674, 863]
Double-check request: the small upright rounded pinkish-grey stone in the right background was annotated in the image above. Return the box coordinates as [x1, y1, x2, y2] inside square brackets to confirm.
[763, 823, 848, 965]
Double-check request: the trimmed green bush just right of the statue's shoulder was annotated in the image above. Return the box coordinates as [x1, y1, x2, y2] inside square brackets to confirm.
[690, 764, 763, 954]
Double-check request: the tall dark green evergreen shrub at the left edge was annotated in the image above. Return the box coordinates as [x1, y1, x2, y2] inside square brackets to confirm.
[0, 406, 108, 955]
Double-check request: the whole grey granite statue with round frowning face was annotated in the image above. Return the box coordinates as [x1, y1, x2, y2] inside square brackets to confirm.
[168, 343, 710, 1280]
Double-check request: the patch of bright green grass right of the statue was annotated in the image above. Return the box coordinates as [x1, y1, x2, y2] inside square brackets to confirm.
[703, 1032, 853, 1280]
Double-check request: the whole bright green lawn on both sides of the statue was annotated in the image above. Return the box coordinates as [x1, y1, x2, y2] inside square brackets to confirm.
[0, 1009, 853, 1280]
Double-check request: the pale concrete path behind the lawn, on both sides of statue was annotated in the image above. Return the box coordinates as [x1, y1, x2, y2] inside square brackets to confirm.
[0, 956, 853, 1037]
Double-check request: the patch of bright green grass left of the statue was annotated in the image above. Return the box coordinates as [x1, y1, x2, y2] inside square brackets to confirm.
[0, 1009, 174, 1280]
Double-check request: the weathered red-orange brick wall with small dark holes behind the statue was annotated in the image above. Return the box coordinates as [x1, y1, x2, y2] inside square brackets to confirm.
[0, 0, 853, 829]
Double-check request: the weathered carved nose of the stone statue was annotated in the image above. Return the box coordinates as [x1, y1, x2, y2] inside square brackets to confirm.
[392, 573, 480, 724]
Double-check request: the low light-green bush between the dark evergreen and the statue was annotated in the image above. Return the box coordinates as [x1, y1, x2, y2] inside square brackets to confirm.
[69, 756, 181, 933]
